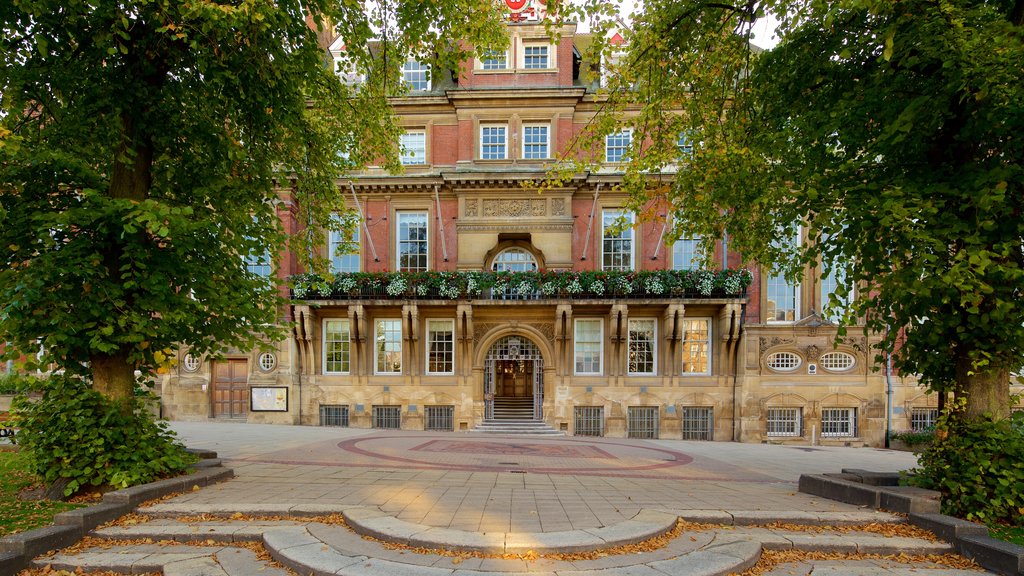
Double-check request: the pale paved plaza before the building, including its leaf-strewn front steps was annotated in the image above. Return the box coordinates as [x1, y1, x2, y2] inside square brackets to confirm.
[28, 422, 995, 576]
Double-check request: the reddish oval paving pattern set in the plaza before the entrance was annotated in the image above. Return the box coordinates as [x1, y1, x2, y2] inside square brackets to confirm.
[337, 435, 693, 475]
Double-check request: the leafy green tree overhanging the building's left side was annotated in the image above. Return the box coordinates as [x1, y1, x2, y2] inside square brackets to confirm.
[0, 0, 504, 401]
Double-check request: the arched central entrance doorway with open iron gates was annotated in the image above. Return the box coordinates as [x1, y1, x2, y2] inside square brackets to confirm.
[483, 336, 544, 420]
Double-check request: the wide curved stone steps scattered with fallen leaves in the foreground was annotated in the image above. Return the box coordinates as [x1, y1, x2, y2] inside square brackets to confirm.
[35, 504, 978, 576]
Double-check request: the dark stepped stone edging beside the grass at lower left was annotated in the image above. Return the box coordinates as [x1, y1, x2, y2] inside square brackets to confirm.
[0, 450, 234, 576]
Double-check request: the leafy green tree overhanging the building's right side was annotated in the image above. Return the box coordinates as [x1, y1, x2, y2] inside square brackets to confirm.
[573, 0, 1024, 418]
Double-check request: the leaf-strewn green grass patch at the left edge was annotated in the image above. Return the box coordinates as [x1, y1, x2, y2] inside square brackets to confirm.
[0, 450, 82, 536]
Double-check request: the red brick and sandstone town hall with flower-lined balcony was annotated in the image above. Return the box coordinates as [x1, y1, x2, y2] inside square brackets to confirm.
[162, 6, 1015, 446]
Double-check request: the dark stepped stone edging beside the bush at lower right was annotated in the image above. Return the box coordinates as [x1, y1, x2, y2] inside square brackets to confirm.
[800, 468, 1024, 576]
